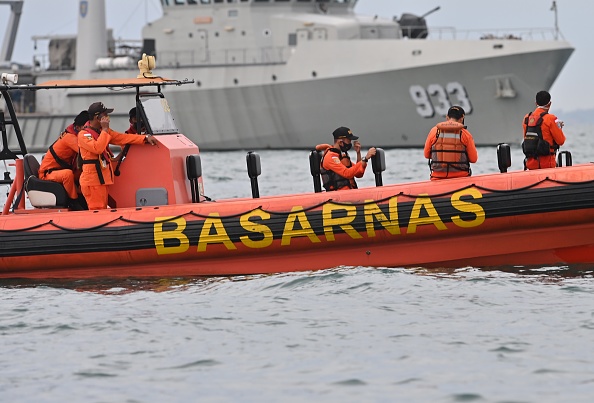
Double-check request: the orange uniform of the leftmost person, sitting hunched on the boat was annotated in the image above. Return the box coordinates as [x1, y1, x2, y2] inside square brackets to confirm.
[38, 124, 78, 199]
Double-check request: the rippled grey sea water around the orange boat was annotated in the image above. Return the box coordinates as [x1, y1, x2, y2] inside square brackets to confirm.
[0, 127, 594, 402]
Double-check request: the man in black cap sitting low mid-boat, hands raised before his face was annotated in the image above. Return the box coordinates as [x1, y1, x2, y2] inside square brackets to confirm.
[316, 126, 375, 191]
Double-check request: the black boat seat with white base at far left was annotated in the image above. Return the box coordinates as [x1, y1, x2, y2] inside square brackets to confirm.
[23, 154, 68, 207]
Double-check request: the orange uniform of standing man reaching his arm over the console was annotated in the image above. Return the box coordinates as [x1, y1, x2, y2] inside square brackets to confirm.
[78, 127, 145, 210]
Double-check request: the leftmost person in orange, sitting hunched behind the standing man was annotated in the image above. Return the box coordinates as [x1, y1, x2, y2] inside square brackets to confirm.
[38, 111, 89, 210]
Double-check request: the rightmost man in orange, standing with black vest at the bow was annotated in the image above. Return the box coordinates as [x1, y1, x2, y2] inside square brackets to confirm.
[522, 91, 565, 170]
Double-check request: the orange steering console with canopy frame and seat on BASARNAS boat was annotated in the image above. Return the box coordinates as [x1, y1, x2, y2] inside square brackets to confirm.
[0, 55, 206, 213]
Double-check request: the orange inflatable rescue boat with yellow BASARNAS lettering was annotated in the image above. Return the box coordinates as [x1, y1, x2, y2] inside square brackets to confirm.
[0, 60, 594, 278]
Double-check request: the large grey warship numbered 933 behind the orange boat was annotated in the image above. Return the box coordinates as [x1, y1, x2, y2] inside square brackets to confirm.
[2, 0, 573, 150]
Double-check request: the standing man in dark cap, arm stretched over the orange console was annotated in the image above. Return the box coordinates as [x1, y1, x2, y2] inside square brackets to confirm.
[78, 102, 157, 210]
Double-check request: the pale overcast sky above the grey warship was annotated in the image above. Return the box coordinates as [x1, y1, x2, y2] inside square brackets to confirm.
[0, 0, 594, 111]
